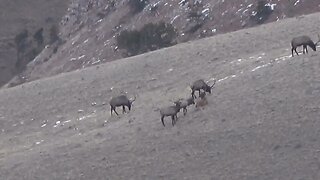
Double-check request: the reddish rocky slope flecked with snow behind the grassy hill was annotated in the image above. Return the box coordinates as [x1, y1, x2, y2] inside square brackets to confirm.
[3, 0, 320, 87]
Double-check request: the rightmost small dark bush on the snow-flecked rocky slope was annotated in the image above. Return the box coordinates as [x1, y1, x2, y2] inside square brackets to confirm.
[251, 0, 273, 24]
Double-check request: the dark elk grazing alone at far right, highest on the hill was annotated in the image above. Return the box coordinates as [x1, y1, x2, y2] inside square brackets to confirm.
[291, 34, 320, 57]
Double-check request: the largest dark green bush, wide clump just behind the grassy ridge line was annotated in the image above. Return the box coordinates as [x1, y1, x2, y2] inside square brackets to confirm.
[117, 22, 177, 56]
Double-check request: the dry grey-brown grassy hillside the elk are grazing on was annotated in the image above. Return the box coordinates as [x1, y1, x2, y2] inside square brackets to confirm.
[0, 13, 320, 180]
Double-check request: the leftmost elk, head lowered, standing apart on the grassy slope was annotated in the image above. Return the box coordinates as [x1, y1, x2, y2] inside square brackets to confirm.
[109, 95, 136, 115]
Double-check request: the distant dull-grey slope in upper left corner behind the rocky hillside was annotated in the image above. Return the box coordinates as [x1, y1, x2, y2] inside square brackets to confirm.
[0, 0, 69, 86]
